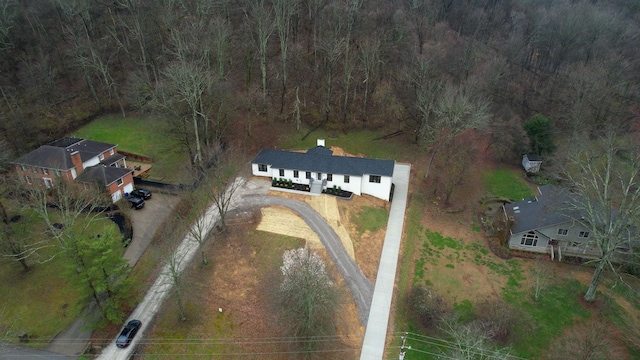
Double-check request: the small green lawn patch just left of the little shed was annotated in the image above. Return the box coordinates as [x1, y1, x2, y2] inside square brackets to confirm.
[483, 170, 534, 201]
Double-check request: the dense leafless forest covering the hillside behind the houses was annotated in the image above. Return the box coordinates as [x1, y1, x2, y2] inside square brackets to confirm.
[0, 0, 640, 165]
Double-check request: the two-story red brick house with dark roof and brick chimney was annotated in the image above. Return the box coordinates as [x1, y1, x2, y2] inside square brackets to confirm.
[12, 138, 133, 202]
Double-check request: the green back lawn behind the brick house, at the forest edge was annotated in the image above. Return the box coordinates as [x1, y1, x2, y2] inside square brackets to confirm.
[73, 115, 188, 183]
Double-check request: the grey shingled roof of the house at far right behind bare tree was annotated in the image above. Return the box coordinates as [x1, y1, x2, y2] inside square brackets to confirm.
[505, 185, 581, 234]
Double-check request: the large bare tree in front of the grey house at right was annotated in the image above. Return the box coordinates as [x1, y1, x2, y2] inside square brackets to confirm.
[562, 132, 640, 302]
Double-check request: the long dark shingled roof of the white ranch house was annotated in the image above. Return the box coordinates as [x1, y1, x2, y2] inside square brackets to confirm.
[252, 146, 395, 176]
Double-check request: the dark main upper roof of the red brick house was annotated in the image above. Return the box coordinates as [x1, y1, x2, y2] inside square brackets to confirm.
[13, 138, 116, 170]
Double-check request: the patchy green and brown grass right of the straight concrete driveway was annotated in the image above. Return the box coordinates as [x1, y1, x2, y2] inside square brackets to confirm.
[396, 170, 637, 359]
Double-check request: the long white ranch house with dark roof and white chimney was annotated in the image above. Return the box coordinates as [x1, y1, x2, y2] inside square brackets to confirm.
[251, 139, 395, 201]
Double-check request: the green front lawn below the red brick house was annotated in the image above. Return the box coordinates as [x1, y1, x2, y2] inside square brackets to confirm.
[0, 204, 124, 347]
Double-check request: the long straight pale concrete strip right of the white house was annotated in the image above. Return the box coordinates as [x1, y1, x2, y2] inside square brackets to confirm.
[360, 164, 411, 360]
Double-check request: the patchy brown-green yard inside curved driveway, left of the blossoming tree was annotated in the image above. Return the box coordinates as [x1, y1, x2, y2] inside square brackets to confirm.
[144, 230, 302, 359]
